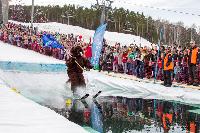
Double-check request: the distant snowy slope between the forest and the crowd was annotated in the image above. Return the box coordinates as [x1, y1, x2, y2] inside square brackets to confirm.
[10, 21, 151, 47]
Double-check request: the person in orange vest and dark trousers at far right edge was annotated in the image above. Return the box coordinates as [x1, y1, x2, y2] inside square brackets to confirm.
[188, 41, 199, 86]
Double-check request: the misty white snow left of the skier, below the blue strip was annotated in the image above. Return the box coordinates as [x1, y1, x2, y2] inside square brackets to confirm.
[0, 71, 72, 108]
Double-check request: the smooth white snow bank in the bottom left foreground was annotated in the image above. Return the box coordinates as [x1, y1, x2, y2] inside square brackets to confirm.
[0, 81, 86, 133]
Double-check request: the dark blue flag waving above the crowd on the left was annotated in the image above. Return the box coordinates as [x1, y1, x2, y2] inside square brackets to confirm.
[42, 34, 64, 48]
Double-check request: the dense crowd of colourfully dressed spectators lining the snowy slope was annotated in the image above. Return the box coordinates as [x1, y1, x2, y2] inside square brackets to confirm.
[0, 23, 200, 85]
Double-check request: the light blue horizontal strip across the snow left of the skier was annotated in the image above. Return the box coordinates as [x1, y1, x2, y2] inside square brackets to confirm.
[0, 61, 67, 72]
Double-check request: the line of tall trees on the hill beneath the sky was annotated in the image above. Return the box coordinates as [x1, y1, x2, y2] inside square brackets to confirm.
[9, 5, 200, 46]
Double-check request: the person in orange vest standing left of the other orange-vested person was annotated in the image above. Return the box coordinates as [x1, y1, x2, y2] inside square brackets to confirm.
[163, 48, 174, 87]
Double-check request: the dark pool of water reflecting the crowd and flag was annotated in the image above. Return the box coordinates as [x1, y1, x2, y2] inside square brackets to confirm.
[46, 97, 200, 133]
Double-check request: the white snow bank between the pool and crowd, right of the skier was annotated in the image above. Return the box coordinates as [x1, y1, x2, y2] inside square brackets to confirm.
[87, 72, 200, 104]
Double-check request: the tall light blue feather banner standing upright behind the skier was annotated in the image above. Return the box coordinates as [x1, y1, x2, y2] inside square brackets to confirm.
[91, 24, 107, 67]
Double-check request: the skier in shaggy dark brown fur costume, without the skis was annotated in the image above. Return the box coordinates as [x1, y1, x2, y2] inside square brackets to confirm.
[66, 46, 92, 93]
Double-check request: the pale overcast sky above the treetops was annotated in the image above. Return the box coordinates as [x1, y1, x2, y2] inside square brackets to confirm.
[11, 0, 200, 27]
